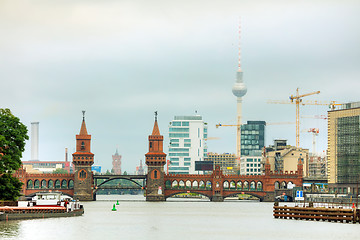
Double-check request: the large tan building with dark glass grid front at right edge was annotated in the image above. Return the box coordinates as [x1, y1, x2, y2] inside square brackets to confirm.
[327, 102, 360, 194]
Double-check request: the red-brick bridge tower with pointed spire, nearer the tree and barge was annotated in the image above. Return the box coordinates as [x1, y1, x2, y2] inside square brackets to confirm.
[73, 111, 94, 201]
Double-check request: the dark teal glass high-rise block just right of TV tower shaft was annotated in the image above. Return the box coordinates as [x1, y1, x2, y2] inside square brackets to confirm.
[241, 121, 266, 156]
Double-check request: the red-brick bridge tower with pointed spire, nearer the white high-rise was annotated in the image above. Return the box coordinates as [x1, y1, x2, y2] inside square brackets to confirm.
[145, 112, 166, 202]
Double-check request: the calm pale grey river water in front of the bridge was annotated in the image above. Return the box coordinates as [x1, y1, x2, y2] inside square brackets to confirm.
[0, 195, 360, 240]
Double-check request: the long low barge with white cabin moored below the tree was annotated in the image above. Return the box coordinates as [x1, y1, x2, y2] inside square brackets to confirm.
[0, 192, 84, 221]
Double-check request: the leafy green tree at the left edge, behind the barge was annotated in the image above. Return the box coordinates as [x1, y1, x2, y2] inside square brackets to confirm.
[0, 108, 29, 201]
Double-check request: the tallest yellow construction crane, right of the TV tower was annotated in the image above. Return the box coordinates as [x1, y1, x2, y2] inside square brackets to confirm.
[268, 88, 320, 148]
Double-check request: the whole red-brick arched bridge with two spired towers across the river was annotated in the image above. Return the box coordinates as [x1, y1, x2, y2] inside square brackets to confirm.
[15, 116, 303, 202]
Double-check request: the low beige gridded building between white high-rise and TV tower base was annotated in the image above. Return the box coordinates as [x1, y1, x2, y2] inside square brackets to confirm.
[207, 152, 238, 174]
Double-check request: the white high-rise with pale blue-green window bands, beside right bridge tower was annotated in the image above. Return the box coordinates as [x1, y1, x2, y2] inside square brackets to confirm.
[169, 115, 207, 174]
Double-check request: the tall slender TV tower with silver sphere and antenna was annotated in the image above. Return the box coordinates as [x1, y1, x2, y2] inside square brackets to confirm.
[232, 23, 247, 159]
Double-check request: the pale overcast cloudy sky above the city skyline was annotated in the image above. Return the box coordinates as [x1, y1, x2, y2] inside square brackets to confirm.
[0, 0, 360, 172]
